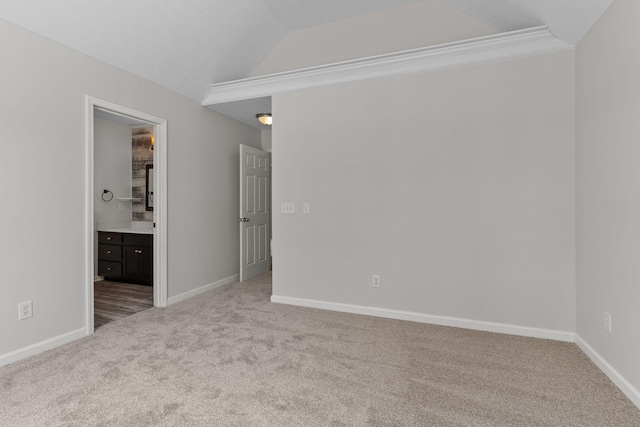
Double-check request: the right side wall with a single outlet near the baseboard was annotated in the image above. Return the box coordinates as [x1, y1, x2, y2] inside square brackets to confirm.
[576, 0, 640, 398]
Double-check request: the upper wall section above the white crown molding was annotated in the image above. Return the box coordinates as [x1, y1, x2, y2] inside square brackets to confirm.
[253, 0, 495, 76]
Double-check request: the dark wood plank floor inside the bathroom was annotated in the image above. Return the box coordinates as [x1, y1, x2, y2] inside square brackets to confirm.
[93, 280, 153, 328]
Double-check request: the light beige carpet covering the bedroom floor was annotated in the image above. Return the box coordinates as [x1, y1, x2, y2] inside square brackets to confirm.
[0, 274, 640, 427]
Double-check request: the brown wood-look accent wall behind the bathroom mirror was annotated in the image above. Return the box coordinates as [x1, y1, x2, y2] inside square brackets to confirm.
[131, 127, 153, 221]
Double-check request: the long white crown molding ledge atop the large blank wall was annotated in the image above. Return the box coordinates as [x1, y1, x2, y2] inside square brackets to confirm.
[202, 26, 574, 106]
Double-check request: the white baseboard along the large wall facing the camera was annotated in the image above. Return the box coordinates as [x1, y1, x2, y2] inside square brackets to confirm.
[271, 295, 575, 342]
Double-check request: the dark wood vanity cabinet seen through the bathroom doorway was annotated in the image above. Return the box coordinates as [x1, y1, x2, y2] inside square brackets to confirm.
[98, 231, 153, 285]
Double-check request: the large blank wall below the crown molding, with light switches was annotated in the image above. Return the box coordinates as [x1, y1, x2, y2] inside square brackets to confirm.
[273, 52, 575, 332]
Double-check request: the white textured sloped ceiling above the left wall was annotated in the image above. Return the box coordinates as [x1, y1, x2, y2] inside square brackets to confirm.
[0, 0, 417, 101]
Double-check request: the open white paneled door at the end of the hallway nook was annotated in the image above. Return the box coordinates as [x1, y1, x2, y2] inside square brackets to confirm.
[238, 145, 271, 282]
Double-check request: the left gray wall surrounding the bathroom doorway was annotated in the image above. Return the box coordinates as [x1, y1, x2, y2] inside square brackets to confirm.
[0, 16, 261, 356]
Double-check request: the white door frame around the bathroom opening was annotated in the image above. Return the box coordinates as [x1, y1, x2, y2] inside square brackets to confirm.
[85, 95, 168, 335]
